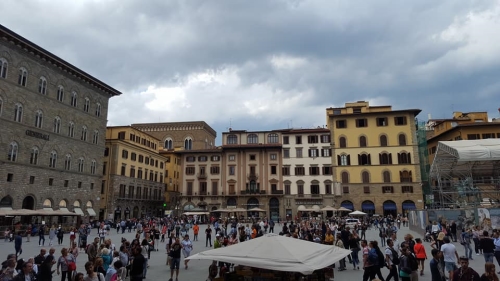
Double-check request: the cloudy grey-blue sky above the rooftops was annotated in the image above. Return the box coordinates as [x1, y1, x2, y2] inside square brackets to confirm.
[0, 0, 500, 142]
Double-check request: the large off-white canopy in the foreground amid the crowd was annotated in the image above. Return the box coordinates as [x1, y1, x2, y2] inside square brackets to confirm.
[186, 233, 351, 275]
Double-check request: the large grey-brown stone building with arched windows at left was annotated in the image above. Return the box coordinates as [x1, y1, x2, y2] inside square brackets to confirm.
[0, 25, 121, 220]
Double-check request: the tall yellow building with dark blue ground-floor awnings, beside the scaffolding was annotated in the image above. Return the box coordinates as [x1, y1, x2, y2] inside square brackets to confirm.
[326, 101, 423, 215]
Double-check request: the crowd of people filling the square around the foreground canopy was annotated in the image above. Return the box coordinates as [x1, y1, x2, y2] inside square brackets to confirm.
[0, 212, 500, 281]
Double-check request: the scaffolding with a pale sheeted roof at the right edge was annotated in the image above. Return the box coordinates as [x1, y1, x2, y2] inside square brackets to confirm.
[428, 139, 500, 209]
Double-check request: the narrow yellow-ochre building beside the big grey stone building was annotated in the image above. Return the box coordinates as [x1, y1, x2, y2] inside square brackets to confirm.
[99, 126, 167, 221]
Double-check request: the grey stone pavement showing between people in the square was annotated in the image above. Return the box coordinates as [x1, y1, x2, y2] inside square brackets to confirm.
[0, 225, 490, 281]
